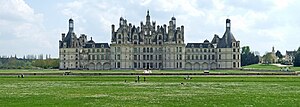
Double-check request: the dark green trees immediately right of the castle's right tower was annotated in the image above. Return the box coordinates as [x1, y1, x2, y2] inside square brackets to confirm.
[241, 46, 259, 66]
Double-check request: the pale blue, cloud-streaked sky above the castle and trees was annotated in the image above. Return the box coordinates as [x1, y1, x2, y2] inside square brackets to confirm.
[0, 0, 300, 58]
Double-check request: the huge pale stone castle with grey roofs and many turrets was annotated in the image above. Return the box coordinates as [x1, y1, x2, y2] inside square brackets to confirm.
[59, 11, 241, 70]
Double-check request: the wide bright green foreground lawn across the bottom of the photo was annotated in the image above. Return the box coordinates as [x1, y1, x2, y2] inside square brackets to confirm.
[0, 76, 300, 107]
